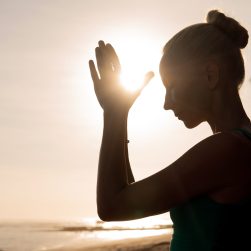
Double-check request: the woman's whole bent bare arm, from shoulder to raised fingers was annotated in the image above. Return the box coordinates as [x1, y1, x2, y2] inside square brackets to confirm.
[90, 39, 245, 221]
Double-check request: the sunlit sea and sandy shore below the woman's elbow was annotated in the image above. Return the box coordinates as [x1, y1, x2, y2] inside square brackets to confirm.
[0, 217, 173, 251]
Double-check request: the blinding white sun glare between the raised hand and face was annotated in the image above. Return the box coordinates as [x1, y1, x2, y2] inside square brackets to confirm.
[103, 32, 176, 135]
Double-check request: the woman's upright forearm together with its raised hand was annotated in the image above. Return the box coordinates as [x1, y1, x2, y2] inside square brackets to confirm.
[89, 41, 153, 218]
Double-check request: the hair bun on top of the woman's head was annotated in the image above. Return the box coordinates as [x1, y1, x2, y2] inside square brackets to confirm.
[207, 10, 249, 49]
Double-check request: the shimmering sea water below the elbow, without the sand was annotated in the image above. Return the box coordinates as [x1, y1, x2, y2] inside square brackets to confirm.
[0, 216, 171, 251]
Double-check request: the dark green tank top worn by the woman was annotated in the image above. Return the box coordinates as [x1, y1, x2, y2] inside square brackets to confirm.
[170, 129, 251, 251]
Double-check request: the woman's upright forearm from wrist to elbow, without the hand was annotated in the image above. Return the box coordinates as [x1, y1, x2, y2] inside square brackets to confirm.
[97, 112, 128, 214]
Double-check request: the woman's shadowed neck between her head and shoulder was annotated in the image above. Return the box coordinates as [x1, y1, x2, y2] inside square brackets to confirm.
[208, 89, 251, 133]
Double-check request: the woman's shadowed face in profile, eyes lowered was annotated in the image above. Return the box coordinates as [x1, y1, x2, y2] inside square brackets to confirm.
[161, 60, 211, 128]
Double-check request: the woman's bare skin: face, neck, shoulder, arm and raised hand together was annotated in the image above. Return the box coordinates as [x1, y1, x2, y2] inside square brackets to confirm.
[89, 41, 251, 221]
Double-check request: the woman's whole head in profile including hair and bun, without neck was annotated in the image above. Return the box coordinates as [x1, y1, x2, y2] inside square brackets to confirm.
[160, 10, 248, 128]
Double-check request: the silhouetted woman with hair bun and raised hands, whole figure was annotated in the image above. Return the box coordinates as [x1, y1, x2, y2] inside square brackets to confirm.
[89, 10, 251, 251]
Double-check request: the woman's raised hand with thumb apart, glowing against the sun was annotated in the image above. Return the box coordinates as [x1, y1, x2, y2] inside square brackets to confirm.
[89, 41, 154, 113]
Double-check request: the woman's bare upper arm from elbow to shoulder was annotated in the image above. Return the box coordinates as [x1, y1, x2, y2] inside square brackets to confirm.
[100, 130, 251, 220]
